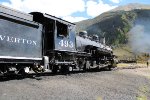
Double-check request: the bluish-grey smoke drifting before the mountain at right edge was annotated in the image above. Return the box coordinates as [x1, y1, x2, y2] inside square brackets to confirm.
[129, 20, 150, 54]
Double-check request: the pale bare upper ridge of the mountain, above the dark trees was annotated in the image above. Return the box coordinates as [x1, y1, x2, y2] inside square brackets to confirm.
[76, 3, 150, 31]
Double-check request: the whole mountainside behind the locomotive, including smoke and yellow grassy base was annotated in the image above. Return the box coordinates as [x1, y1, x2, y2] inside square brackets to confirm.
[76, 4, 150, 57]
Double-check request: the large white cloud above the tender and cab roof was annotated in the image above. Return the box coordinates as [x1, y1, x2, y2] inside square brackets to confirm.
[2, 0, 85, 17]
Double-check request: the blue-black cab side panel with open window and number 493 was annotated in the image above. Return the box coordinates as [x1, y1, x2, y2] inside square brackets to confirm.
[55, 21, 76, 52]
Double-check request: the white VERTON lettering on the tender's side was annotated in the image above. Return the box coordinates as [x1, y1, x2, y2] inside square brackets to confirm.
[0, 35, 37, 46]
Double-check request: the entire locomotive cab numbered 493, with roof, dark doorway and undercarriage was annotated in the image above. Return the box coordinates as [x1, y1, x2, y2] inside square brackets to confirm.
[31, 12, 76, 72]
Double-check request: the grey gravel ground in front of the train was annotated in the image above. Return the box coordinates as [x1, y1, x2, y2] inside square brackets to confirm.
[0, 68, 150, 100]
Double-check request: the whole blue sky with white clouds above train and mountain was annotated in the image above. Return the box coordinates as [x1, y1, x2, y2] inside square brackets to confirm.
[0, 0, 150, 22]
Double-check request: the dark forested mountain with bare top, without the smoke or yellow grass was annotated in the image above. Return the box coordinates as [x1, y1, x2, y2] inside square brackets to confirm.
[76, 4, 150, 46]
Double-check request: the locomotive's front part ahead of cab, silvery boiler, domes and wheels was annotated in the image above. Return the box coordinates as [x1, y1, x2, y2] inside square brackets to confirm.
[76, 31, 114, 69]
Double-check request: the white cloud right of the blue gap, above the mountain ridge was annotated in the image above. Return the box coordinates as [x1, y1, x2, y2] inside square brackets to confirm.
[86, 0, 117, 17]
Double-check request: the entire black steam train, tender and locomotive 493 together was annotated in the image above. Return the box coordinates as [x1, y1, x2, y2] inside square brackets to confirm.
[0, 6, 114, 75]
